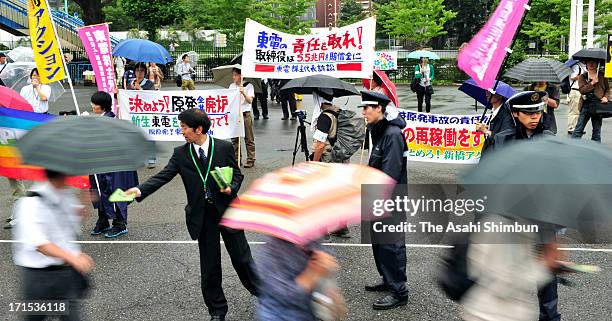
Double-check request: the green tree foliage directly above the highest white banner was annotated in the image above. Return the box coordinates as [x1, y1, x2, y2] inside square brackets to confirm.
[251, 0, 314, 34]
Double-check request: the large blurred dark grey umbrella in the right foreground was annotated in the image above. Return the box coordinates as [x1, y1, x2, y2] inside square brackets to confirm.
[461, 137, 612, 234]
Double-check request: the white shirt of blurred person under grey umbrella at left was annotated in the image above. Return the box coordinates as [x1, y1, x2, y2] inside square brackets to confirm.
[13, 182, 83, 269]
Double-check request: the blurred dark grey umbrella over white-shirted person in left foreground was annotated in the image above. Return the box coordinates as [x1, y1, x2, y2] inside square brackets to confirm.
[16, 116, 155, 176]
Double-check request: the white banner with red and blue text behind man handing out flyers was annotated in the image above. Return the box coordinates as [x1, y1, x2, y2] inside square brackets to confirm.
[119, 89, 244, 141]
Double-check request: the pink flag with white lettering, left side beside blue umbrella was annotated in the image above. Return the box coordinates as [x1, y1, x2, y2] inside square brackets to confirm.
[79, 23, 116, 111]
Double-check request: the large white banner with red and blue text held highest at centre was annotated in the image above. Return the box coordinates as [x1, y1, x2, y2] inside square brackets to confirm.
[242, 17, 376, 79]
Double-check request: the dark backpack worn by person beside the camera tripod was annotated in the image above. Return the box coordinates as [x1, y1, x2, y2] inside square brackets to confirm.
[322, 109, 365, 163]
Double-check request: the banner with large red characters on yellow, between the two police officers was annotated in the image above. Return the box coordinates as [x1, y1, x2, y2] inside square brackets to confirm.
[399, 109, 486, 164]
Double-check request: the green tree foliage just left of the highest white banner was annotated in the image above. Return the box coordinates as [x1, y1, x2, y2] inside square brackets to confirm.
[183, 0, 255, 45]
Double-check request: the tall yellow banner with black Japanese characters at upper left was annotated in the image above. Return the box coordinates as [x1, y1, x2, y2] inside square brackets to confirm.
[28, 0, 66, 84]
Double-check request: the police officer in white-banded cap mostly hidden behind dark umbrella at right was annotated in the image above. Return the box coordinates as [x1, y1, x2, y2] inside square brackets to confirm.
[482, 91, 561, 321]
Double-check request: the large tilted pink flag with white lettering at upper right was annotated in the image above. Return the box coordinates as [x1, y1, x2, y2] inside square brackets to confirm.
[457, 0, 529, 88]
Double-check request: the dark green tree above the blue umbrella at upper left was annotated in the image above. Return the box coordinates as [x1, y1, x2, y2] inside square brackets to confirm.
[121, 0, 183, 40]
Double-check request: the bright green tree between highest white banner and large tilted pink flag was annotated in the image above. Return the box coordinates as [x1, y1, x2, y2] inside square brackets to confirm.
[379, 0, 457, 47]
